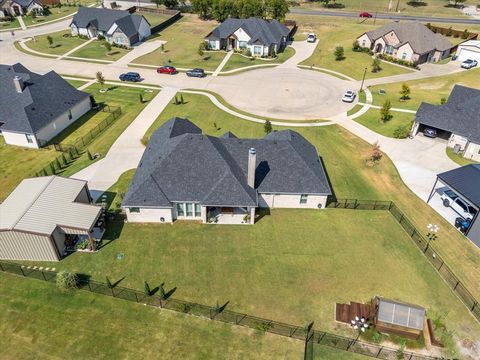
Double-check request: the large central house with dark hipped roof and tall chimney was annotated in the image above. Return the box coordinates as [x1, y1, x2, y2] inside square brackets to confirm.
[122, 118, 332, 224]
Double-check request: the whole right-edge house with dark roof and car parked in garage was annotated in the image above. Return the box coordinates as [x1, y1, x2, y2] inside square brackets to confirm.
[412, 85, 480, 161]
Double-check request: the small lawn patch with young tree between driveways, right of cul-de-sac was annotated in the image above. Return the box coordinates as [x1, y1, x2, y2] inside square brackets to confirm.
[354, 109, 415, 137]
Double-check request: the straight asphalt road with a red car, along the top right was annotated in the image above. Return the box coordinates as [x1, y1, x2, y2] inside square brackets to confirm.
[290, 9, 480, 25]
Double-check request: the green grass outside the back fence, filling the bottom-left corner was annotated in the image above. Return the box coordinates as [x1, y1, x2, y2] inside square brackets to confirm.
[0, 273, 304, 360]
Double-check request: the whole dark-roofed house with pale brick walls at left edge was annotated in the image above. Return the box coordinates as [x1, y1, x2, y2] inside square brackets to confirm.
[0, 63, 92, 148]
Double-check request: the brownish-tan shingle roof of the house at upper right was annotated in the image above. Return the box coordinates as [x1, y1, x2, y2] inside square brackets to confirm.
[366, 21, 453, 54]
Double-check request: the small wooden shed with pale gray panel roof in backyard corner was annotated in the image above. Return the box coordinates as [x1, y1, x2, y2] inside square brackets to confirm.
[374, 297, 425, 339]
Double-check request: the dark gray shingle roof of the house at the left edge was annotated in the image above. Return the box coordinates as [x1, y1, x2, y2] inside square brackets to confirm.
[0, 63, 90, 134]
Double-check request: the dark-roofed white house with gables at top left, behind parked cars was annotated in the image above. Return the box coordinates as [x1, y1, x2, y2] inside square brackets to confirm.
[70, 7, 151, 47]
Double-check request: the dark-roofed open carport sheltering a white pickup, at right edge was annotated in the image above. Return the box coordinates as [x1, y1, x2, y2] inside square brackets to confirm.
[427, 164, 480, 247]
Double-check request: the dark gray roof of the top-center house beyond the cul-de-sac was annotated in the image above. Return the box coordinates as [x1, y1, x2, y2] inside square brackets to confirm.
[206, 17, 290, 46]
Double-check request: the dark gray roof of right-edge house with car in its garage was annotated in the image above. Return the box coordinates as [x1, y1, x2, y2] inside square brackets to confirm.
[415, 85, 480, 144]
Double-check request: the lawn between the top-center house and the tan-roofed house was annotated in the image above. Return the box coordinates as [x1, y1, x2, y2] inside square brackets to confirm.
[294, 16, 413, 80]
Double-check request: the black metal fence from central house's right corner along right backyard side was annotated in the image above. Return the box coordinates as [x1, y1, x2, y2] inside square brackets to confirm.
[327, 199, 480, 321]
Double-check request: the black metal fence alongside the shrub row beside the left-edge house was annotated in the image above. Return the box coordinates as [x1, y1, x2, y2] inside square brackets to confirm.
[35, 105, 122, 176]
